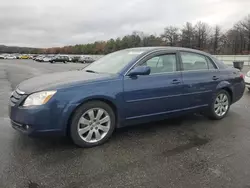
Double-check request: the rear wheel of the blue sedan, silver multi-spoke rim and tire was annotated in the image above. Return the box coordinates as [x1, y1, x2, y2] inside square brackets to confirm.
[208, 89, 231, 120]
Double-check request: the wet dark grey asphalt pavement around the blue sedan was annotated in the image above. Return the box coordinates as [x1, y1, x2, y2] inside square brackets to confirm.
[0, 60, 250, 188]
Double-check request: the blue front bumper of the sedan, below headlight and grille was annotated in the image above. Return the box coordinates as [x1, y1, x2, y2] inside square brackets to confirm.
[9, 97, 73, 135]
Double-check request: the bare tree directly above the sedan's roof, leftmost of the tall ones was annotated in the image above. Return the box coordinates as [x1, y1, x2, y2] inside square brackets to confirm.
[161, 26, 179, 46]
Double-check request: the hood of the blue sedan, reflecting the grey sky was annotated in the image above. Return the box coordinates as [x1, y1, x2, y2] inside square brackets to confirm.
[18, 70, 114, 94]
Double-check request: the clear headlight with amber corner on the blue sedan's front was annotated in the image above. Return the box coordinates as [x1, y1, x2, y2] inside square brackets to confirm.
[23, 91, 56, 106]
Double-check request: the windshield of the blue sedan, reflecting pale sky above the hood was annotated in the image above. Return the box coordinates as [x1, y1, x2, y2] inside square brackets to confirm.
[84, 49, 143, 74]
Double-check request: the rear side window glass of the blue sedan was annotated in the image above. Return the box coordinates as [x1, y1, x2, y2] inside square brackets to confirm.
[180, 52, 216, 70]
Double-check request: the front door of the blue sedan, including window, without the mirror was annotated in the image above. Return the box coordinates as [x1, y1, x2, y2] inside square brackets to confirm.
[124, 52, 183, 120]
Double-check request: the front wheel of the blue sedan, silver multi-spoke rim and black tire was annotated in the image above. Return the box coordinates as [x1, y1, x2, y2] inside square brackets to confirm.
[70, 101, 116, 148]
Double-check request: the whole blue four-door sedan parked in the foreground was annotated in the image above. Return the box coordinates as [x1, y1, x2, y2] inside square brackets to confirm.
[9, 47, 245, 147]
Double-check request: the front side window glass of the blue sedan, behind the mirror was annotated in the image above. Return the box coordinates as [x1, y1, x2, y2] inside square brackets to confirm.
[140, 54, 177, 74]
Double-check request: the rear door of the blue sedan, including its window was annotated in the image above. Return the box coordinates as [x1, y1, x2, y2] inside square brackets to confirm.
[179, 51, 221, 108]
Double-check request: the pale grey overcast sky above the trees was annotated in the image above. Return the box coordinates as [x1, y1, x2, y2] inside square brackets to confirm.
[0, 0, 250, 47]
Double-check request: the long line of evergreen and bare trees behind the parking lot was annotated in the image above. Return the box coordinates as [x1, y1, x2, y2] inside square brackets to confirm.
[0, 14, 250, 55]
